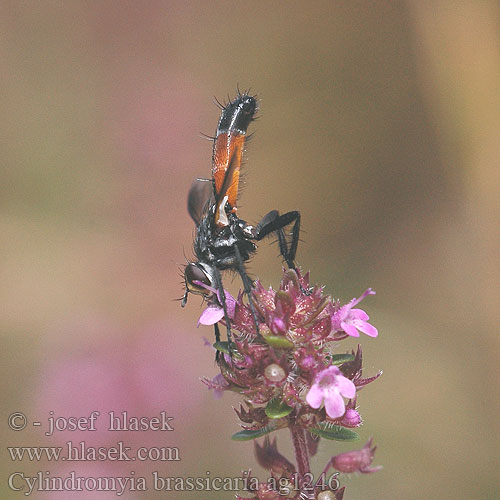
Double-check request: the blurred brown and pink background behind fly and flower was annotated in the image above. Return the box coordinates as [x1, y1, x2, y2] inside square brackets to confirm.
[0, 0, 500, 500]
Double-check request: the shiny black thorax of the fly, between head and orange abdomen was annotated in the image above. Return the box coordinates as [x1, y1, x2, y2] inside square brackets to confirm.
[194, 209, 257, 269]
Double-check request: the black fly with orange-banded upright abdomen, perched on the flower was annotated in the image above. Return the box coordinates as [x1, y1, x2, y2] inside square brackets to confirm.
[181, 91, 300, 352]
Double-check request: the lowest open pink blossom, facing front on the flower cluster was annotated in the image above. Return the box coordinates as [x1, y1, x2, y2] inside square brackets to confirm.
[306, 366, 356, 418]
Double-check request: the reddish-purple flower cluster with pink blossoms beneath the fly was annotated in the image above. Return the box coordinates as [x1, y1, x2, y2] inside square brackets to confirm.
[200, 270, 381, 500]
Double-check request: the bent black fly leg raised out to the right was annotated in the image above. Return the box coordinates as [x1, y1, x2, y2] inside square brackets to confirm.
[254, 210, 300, 269]
